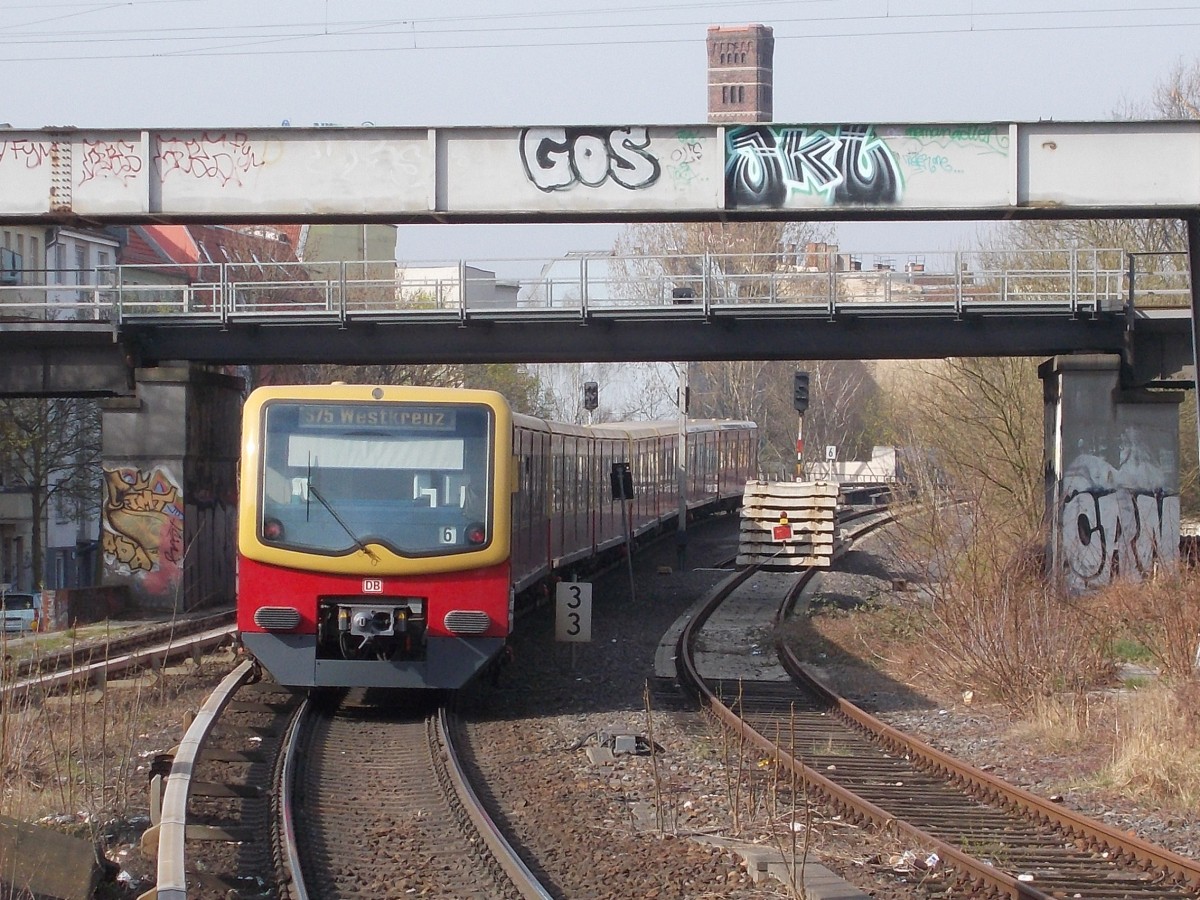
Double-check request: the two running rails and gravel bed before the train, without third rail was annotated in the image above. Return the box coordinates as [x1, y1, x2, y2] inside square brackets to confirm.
[286, 692, 548, 900]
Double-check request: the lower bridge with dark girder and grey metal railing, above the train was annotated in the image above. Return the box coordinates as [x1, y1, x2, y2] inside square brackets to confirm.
[0, 248, 1192, 396]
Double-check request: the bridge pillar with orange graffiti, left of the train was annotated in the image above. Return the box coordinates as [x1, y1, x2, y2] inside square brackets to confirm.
[101, 364, 242, 611]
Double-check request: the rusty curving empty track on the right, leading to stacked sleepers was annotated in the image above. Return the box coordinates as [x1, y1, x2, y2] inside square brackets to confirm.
[677, 532, 1200, 900]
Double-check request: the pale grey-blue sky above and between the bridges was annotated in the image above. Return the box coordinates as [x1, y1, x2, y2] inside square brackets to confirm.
[0, 0, 1200, 262]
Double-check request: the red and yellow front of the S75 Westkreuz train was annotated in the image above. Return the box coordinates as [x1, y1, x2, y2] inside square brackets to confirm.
[238, 385, 514, 689]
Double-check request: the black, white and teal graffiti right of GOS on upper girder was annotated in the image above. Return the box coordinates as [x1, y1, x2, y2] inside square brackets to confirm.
[725, 125, 904, 208]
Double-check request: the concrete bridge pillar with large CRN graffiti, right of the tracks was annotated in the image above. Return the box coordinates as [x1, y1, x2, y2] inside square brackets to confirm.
[1038, 355, 1183, 593]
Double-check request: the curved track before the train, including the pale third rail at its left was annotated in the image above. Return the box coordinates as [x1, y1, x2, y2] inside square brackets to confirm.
[143, 681, 550, 900]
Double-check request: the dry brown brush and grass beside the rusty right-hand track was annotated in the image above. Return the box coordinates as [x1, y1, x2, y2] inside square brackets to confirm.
[804, 509, 1200, 815]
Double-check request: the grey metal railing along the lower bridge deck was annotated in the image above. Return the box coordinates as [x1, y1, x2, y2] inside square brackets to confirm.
[0, 245, 1190, 326]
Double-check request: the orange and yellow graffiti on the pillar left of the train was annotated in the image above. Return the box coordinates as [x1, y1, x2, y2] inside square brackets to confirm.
[101, 466, 184, 594]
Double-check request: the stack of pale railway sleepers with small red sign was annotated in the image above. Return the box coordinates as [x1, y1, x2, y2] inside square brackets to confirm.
[737, 481, 842, 569]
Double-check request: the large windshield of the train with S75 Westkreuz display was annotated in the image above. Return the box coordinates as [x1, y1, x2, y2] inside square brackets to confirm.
[258, 402, 494, 556]
